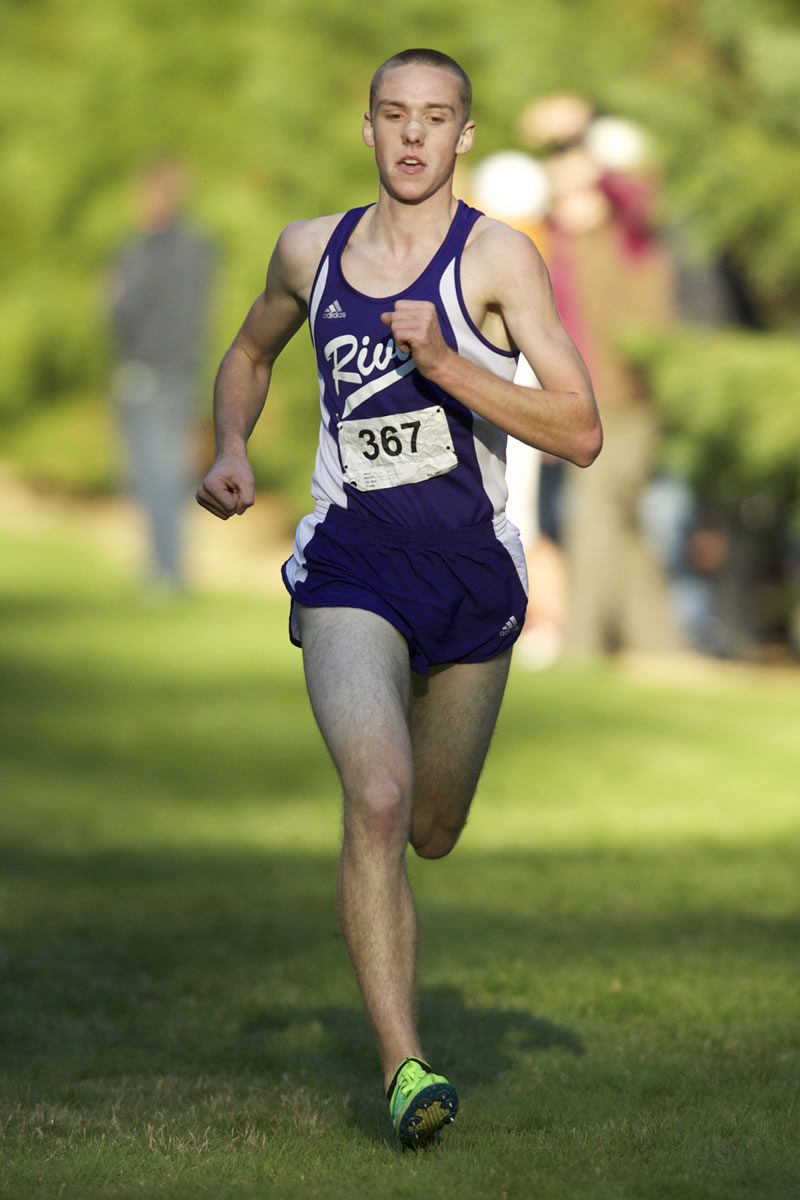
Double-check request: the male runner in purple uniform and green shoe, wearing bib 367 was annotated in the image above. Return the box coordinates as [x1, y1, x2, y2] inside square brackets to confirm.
[197, 49, 602, 1146]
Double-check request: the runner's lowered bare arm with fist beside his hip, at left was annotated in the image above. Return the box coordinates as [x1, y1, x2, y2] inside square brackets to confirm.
[197, 222, 319, 521]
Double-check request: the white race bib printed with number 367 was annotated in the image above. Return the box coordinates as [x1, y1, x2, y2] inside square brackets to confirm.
[337, 406, 458, 492]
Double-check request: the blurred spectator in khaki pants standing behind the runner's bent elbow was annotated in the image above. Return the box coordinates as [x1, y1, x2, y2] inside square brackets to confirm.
[518, 95, 685, 656]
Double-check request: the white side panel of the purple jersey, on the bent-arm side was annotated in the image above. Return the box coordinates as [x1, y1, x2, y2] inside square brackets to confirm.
[439, 258, 517, 516]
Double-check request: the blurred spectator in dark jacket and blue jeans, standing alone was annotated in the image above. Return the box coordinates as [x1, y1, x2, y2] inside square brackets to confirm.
[109, 160, 213, 590]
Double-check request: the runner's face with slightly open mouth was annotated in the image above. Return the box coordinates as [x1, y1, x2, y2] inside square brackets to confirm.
[362, 65, 475, 203]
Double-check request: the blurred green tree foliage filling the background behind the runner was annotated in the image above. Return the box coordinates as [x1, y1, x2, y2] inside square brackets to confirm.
[0, 0, 800, 525]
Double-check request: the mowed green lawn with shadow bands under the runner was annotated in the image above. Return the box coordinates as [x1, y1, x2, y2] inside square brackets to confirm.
[0, 518, 800, 1200]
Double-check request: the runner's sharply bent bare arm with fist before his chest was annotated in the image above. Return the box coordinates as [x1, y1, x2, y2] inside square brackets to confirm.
[381, 222, 602, 467]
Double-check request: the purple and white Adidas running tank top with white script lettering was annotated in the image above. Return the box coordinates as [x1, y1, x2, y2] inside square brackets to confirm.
[308, 202, 517, 530]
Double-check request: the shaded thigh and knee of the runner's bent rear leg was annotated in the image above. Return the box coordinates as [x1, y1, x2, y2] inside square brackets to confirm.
[409, 650, 511, 858]
